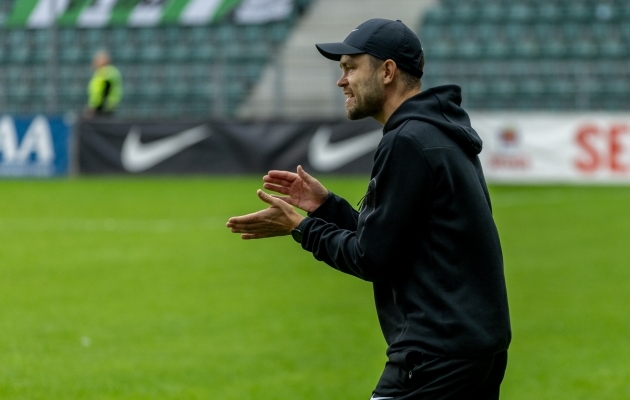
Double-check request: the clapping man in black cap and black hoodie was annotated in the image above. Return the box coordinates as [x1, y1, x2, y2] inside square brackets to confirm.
[227, 19, 511, 400]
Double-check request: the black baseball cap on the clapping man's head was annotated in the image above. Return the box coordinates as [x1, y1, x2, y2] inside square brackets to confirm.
[315, 18, 423, 78]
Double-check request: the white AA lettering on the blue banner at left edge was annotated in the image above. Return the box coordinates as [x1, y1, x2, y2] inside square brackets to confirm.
[0, 115, 55, 175]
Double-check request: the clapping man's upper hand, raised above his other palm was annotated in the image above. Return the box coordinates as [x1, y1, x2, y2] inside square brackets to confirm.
[263, 165, 328, 213]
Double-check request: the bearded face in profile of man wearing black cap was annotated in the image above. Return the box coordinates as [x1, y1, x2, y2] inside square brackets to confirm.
[337, 54, 385, 120]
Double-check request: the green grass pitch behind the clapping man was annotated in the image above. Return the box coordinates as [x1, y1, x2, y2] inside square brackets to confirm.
[0, 176, 630, 400]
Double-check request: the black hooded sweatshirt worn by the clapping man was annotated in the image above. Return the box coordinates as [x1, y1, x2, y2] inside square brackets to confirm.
[299, 85, 511, 358]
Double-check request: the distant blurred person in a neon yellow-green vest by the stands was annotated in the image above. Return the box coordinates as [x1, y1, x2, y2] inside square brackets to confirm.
[85, 50, 122, 118]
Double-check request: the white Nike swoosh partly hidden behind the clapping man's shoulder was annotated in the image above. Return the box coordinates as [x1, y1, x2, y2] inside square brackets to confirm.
[308, 126, 383, 172]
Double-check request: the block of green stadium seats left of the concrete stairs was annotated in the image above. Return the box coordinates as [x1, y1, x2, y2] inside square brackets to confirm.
[0, 0, 311, 116]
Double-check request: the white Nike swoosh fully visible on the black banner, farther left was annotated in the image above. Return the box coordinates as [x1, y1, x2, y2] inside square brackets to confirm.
[120, 125, 210, 172]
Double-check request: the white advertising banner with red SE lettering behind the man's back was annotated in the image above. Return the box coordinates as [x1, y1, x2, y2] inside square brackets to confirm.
[470, 113, 630, 184]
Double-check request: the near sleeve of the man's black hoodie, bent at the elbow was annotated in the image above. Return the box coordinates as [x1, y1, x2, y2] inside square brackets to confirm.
[300, 132, 432, 282]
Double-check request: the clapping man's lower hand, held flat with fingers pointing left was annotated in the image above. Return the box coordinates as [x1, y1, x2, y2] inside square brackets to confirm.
[226, 189, 304, 239]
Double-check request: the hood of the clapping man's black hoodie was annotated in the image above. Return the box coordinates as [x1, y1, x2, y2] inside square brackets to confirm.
[383, 85, 482, 155]
